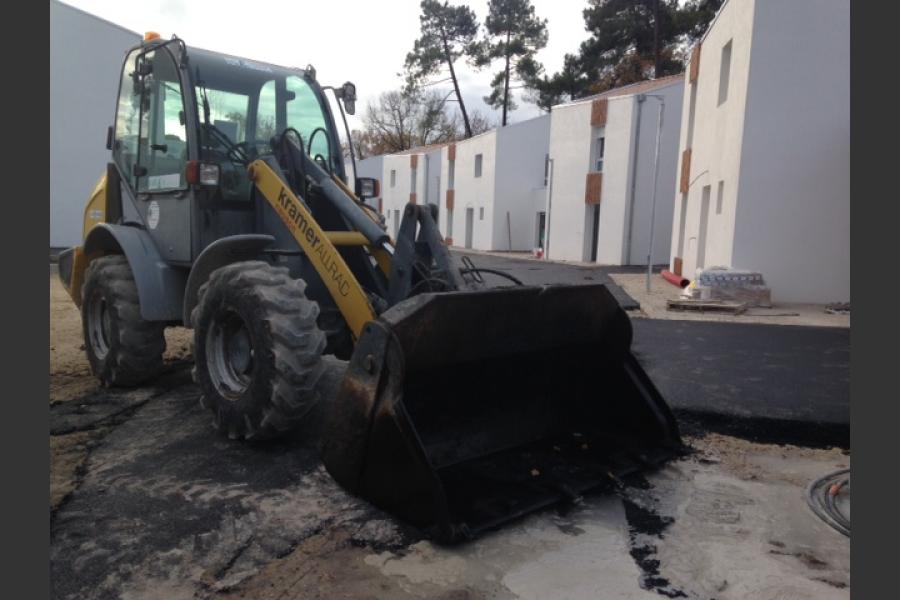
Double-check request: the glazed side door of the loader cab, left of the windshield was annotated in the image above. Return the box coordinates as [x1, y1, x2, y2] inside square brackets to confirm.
[113, 48, 191, 263]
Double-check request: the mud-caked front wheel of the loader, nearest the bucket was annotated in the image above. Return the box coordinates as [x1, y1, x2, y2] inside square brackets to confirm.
[191, 261, 325, 439]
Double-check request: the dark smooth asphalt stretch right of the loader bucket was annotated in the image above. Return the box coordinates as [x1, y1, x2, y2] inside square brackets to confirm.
[631, 319, 850, 447]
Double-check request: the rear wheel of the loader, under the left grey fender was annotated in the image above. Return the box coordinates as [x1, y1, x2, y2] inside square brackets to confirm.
[81, 254, 166, 387]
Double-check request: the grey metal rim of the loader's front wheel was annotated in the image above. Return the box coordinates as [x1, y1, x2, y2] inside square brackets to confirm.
[206, 311, 254, 401]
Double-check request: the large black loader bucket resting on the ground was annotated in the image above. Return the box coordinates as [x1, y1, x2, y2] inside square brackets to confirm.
[321, 285, 681, 542]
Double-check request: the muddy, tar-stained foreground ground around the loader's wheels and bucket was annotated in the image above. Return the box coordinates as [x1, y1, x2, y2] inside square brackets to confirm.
[50, 273, 850, 600]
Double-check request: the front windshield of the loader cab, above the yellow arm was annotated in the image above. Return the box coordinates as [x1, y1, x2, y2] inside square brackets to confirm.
[190, 49, 340, 169]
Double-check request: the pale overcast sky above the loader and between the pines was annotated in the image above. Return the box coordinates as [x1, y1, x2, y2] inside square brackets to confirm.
[63, 0, 588, 128]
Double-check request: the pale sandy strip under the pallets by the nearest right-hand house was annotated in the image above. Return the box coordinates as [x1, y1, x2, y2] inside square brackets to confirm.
[610, 273, 850, 327]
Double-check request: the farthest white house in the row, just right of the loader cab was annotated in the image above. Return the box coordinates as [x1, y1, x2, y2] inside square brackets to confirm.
[381, 144, 444, 238]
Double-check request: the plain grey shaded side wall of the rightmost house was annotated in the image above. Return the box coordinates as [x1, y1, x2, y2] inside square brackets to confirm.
[734, 0, 850, 302]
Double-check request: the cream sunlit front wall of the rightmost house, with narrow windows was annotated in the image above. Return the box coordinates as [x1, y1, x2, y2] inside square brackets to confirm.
[671, 0, 756, 279]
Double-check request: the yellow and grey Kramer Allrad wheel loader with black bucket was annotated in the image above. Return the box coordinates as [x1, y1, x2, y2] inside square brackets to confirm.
[59, 34, 681, 542]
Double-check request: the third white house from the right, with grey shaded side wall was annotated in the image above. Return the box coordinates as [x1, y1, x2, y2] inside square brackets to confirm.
[440, 115, 550, 250]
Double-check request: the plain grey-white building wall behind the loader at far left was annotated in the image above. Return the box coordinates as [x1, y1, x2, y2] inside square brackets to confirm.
[50, 0, 141, 248]
